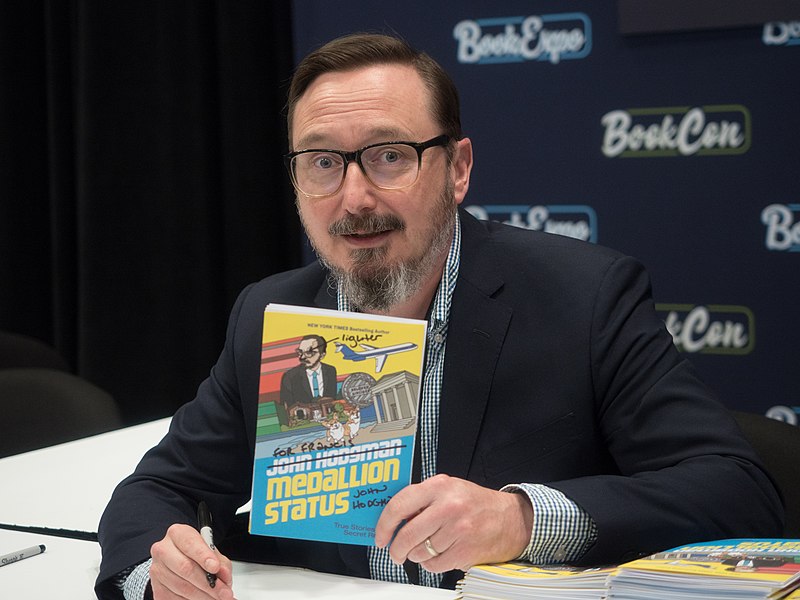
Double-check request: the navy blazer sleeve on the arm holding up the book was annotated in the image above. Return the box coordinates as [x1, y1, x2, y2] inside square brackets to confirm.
[548, 257, 783, 564]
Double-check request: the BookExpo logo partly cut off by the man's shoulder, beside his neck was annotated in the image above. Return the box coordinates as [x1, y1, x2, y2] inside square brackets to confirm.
[466, 204, 597, 243]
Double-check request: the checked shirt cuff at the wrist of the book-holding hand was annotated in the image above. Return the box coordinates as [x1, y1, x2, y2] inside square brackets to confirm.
[500, 483, 597, 565]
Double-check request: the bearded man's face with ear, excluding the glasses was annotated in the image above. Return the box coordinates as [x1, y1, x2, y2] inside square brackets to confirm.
[291, 65, 471, 309]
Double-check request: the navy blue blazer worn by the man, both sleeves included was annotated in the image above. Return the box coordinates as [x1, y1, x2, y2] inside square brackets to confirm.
[98, 210, 783, 591]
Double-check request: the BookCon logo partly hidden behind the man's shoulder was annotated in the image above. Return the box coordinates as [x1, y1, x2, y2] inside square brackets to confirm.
[656, 304, 755, 354]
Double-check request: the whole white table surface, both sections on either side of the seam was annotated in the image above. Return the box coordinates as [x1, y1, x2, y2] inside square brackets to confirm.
[0, 419, 455, 600]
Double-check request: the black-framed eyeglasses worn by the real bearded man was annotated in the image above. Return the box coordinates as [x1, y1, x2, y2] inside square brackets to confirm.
[284, 134, 451, 198]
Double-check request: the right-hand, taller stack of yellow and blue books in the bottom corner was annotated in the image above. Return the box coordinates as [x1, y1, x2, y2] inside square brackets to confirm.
[609, 539, 800, 600]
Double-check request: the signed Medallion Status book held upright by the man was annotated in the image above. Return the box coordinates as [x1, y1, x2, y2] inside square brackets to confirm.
[250, 304, 427, 546]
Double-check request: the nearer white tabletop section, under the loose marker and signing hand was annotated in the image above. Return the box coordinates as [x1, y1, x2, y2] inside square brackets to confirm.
[0, 529, 456, 600]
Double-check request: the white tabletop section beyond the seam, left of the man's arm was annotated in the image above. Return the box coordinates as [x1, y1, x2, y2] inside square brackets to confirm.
[0, 419, 171, 533]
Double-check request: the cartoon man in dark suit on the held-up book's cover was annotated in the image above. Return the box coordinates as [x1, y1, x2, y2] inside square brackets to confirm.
[281, 334, 336, 419]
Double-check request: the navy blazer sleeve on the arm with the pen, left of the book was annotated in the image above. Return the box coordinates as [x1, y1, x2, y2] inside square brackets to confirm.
[97, 288, 259, 597]
